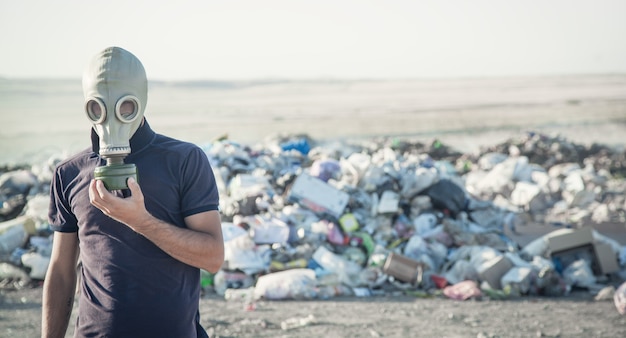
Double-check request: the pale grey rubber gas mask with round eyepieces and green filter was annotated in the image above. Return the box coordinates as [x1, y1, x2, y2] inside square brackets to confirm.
[83, 47, 148, 190]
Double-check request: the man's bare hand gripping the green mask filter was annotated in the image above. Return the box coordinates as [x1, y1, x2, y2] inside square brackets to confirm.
[89, 177, 152, 233]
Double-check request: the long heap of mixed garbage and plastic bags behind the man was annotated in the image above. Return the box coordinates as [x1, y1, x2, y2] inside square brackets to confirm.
[0, 133, 626, 309]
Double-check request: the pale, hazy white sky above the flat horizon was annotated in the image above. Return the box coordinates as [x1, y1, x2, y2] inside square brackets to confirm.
[0, 0, 626, 80]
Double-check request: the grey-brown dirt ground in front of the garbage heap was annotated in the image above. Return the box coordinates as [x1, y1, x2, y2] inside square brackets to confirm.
[0, 288, 626, 338]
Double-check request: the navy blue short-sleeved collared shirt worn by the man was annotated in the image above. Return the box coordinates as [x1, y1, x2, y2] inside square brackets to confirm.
[49, 121, 219, 337]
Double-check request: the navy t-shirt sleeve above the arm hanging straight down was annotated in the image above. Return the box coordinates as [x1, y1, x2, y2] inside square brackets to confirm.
[48, 167, 78, 232]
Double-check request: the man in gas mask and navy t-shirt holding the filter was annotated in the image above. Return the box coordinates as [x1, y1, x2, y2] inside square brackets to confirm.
[42, 47, 224, 337]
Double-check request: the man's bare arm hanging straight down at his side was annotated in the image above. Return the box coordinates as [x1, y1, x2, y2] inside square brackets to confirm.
[41, 232, 79, 338]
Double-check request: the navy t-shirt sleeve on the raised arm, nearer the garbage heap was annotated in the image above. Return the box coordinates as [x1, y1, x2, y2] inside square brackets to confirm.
[181, 147, 219, 217]
